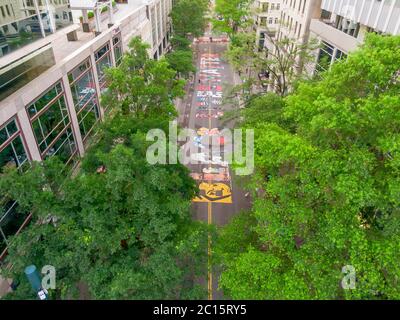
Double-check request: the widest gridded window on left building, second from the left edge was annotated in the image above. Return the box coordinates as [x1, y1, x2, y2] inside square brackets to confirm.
[26, 83, 77, 164]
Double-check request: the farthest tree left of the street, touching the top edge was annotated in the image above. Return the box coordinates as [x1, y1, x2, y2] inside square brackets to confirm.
[171, 0, 208, 38]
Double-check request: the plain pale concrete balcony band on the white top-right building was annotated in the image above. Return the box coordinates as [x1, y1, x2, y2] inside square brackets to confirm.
[310, 19, 361, 53]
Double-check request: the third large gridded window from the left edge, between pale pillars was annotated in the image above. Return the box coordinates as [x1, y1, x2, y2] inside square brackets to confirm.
[68, 59, 100, 141]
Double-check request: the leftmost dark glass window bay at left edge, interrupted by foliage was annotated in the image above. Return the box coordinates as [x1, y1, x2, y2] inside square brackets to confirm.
[0, 119, 29, 256]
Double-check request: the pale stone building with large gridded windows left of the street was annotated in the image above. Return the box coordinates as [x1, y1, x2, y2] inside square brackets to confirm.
[0, 0, 172, 272]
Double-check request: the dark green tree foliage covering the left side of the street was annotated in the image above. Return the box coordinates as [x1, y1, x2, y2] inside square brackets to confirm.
[0, 39, 208, 299]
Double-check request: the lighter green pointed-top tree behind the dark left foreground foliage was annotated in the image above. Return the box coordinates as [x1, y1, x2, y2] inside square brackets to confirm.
[102, 37, 184, 117]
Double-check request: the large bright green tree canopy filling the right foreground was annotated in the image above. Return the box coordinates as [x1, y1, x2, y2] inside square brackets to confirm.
[220, 34, 400, 299]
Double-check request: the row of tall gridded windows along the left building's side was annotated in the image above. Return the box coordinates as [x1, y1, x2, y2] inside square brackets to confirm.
[0, 34, 122, 257]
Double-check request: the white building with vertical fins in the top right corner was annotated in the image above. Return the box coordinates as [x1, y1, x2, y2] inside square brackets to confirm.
[310, 0, 400, 72]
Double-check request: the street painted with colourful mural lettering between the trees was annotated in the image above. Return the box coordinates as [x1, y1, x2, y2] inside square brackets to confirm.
[180, 27, 250, 300]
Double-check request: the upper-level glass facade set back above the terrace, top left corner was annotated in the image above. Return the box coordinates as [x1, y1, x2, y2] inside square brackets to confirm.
[0, 0, 72, 57]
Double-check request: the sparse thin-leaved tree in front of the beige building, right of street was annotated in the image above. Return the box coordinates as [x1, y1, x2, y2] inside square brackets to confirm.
[227, 32, 318, 104]
